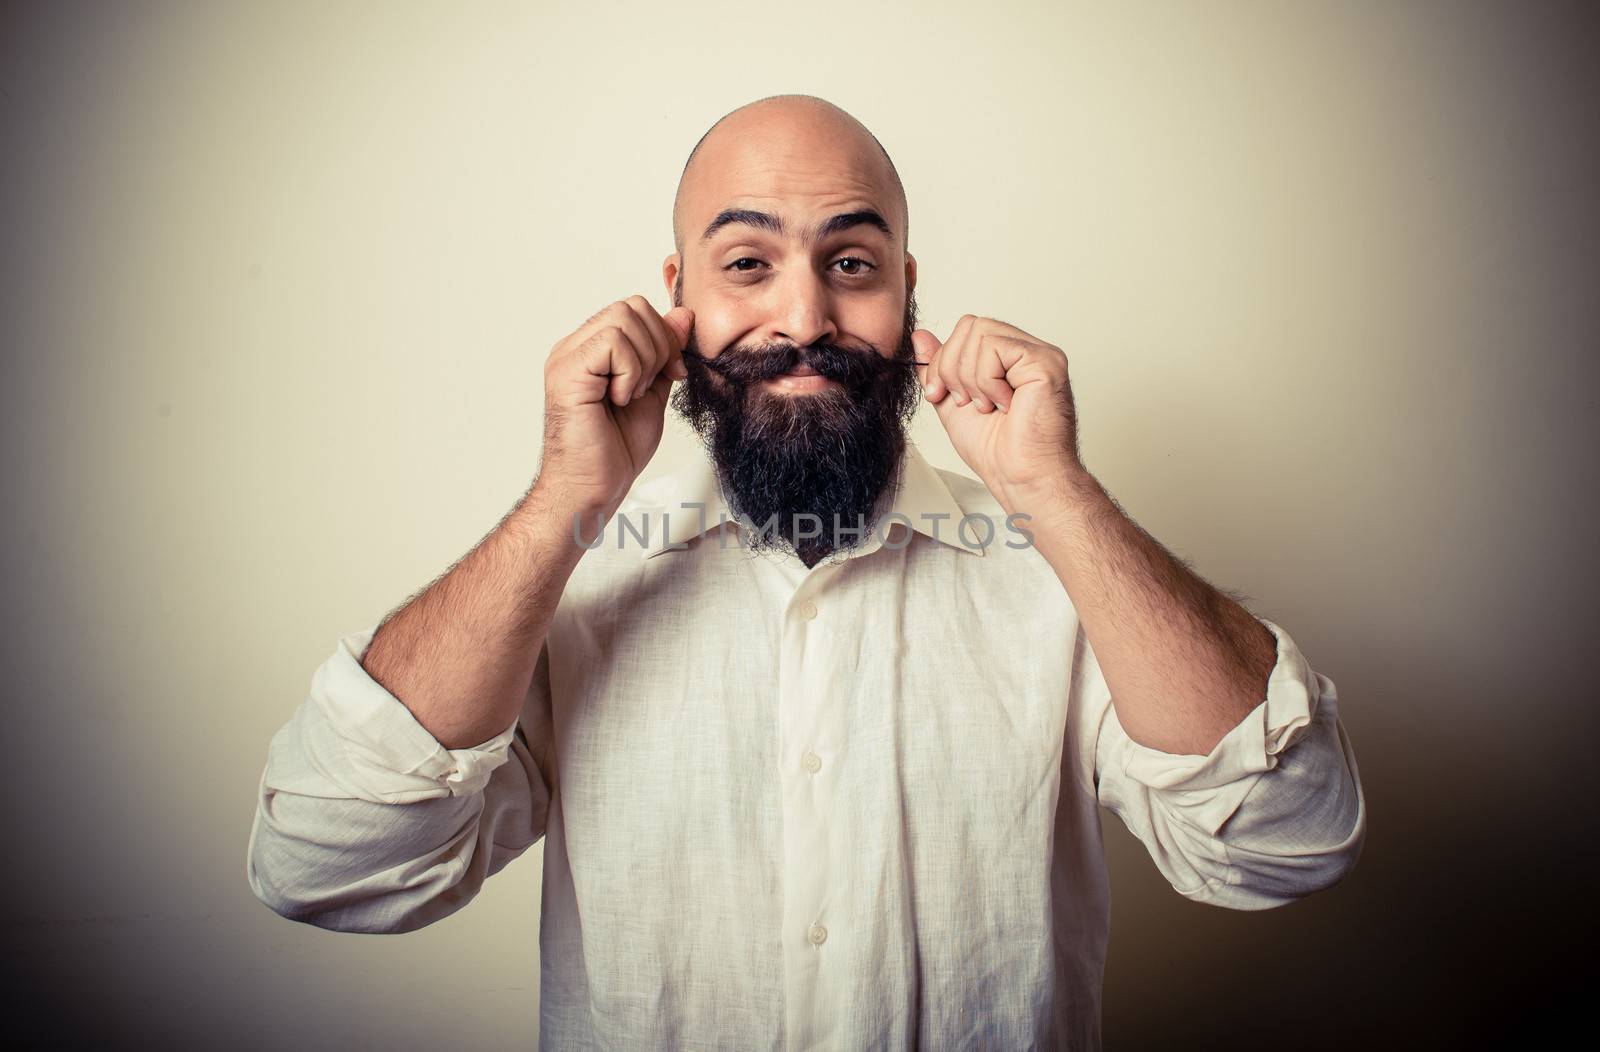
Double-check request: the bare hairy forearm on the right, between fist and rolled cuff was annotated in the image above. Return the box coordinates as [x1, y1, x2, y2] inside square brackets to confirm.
[1021, 470, 1277, 756]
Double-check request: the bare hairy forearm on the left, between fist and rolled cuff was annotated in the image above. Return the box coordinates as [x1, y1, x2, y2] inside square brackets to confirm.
[362, 484, 595, 748]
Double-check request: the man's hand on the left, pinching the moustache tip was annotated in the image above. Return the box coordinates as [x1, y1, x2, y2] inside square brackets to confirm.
[534, 296, 694, 518]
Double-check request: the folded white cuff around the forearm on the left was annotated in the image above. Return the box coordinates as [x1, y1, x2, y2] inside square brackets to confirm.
[310, 625, 520, 803]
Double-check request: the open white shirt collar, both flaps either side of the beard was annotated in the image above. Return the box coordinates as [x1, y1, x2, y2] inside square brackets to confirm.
[624, 438, 984, 560]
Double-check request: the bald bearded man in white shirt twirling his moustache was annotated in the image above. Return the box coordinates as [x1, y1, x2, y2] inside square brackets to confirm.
[248, 96, 1365, 1049]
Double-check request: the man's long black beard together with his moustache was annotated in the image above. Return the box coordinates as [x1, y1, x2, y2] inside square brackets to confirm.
[670, 294, 922, 568]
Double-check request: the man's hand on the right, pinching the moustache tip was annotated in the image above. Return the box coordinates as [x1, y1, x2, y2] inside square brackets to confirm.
[912, 315, 1088, 512]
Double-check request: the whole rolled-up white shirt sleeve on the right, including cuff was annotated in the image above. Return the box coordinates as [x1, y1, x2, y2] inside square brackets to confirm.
[1078, 619, 1366, 910]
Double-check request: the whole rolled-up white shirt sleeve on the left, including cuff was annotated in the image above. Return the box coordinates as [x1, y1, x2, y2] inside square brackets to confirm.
[246, 625, 554, 932]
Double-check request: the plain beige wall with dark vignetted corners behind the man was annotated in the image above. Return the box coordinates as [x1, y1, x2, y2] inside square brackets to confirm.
[0, 2, 1600, 1049]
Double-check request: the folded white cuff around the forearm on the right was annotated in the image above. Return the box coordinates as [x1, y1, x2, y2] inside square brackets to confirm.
[1123, 617, 1322, 835]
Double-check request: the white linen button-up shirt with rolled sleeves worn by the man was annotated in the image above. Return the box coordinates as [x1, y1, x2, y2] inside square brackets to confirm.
[246, 446, 1366, 1050]
